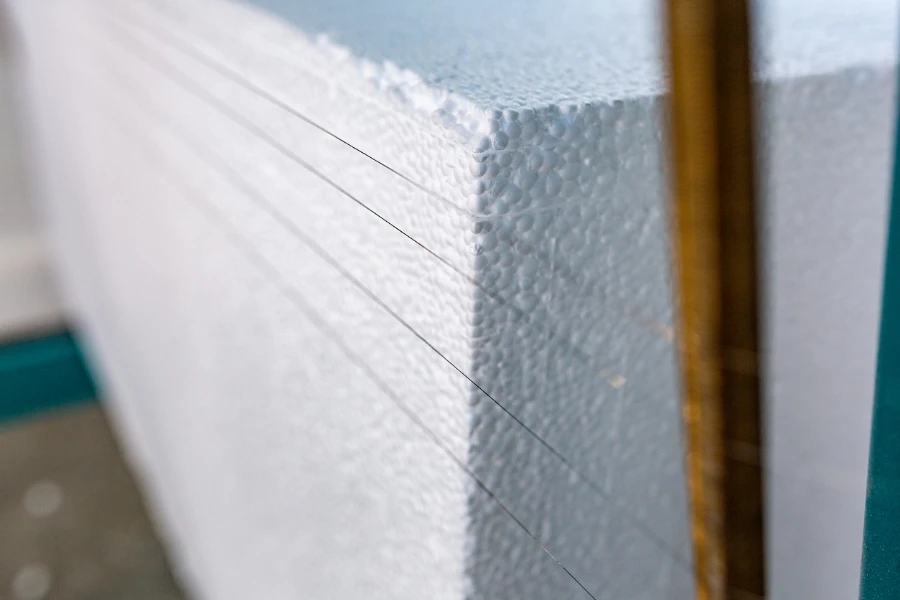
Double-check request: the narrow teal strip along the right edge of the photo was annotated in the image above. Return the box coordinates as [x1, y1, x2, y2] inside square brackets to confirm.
[860, 69, 900, 600]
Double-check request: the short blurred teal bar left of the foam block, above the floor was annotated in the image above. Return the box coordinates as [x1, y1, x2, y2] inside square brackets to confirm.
[0, 333, 97, 423]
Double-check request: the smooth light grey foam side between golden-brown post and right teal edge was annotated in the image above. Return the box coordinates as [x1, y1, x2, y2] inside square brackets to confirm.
[761, 68, 896, 599]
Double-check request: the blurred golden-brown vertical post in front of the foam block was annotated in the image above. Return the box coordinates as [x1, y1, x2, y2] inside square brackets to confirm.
[668, 0, 765, 600]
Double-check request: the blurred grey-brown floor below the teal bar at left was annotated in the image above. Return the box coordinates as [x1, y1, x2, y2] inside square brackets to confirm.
[0, 404, 184, 600]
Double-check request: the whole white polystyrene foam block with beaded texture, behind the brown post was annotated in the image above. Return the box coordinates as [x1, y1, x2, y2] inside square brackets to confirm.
[8, 0, 895, 600]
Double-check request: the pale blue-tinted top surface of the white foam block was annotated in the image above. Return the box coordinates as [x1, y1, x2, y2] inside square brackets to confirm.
[248, 0, 897, 108]
